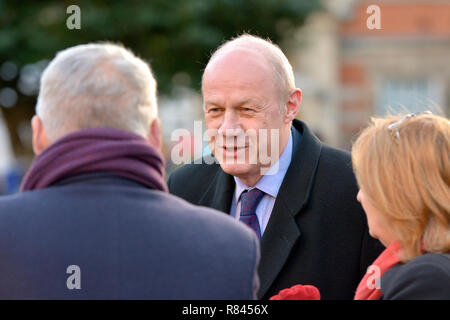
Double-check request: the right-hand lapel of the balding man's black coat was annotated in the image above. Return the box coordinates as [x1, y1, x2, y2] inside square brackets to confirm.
[258, 120, 322, 298]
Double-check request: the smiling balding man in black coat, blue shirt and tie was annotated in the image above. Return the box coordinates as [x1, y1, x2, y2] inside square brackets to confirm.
[168, 35, 383, 299]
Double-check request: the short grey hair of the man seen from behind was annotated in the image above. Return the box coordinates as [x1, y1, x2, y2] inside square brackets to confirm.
[36, 43, 158, 141]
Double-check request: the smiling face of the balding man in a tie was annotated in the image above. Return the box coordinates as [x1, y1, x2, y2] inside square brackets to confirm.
[203, 49, 289, 185]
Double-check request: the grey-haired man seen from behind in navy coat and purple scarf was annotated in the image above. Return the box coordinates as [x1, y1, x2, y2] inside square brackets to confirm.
[0, 43, 259, 300]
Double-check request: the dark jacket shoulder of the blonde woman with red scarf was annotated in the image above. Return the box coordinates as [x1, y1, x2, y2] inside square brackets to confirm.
[381, 253, 450, 300]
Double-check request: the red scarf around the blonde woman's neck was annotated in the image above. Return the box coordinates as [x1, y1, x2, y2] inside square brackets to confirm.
[353, 241, 400, 300]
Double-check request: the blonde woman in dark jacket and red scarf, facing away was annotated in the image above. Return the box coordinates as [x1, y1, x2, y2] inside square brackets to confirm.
[352, 112, 450, 300]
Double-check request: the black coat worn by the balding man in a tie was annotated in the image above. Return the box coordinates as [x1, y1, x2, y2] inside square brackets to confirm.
[168, 120, 383, 299]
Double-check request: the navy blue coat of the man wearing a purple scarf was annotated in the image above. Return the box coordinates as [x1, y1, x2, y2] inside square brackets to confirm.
[0, 174, 259, 299]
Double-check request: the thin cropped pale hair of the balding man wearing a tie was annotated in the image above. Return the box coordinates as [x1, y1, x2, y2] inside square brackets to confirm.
[203, 34, 295, 107]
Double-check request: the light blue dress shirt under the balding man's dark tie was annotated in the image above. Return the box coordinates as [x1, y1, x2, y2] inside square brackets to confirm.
[230, 131, 293, 236]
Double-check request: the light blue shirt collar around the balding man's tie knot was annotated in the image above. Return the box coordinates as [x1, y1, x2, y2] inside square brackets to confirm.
[234, 131, 293, 203]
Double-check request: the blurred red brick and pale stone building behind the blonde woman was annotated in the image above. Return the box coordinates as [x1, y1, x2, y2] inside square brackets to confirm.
[292, 0, 450, 149]
